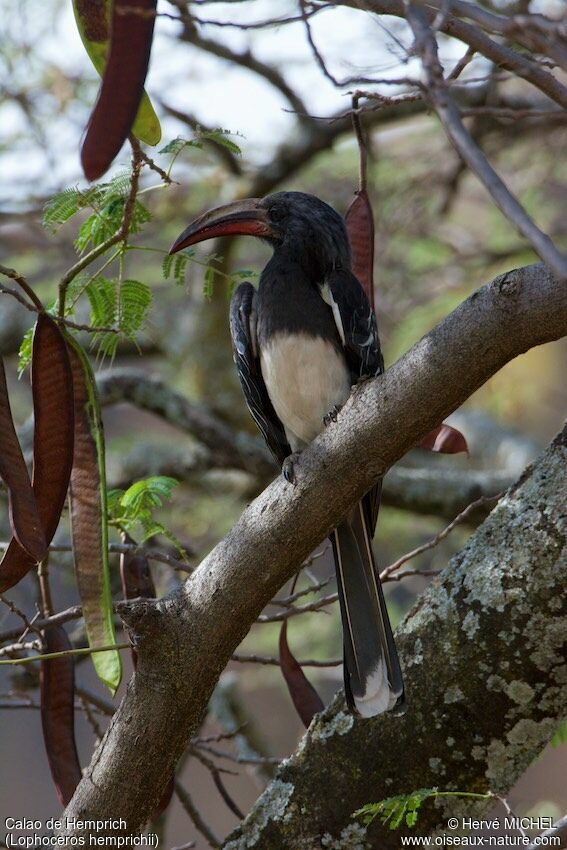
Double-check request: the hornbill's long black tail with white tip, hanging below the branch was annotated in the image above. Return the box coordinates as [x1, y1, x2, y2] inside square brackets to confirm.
[331, 502, 404, 717]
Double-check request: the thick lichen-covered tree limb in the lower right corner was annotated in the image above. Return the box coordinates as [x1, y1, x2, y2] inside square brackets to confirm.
[223, 429, 567, 850]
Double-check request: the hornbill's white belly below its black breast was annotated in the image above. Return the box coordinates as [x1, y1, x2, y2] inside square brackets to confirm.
[260, 334, 350, 451]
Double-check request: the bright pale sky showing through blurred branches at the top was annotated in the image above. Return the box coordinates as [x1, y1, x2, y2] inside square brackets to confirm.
[0, 0, 512, 202]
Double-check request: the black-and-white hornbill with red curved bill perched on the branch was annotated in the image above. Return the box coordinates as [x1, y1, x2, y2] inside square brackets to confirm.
[170, 192, 404, 717]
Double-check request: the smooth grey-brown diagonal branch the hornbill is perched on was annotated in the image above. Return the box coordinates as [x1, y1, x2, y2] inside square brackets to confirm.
[58, 265, 567, 835]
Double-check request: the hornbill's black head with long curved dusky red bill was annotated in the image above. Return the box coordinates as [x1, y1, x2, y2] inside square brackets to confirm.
[170, 192, 350, 274]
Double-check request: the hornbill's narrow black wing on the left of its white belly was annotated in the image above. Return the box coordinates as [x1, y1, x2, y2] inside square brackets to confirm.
[230, 282, 291, 464]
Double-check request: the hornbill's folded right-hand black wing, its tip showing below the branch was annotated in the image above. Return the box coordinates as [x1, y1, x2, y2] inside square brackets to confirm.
[326, 269, 384, 534]
